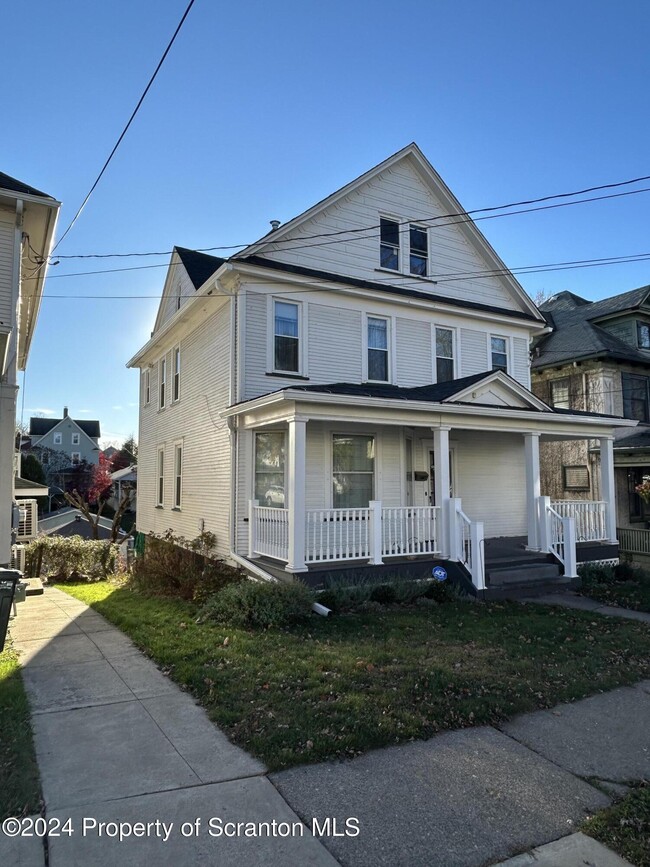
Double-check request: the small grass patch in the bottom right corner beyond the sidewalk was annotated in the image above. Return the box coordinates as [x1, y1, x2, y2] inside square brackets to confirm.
[580, 783, 650, 867]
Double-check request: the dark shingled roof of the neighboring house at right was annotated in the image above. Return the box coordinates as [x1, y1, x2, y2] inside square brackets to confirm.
[531, 286, 650, 370]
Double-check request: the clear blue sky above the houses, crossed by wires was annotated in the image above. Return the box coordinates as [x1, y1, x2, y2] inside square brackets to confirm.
[5, 0, 650, 441]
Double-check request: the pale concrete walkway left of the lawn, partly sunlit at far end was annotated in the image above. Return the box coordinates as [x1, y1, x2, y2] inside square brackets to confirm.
[0, 588, 337, 867]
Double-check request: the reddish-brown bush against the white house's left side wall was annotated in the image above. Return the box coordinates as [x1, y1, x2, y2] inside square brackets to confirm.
[133, 530, 245, 604]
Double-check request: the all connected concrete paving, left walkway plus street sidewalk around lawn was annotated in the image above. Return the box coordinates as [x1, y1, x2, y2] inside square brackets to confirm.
[6, 588, 650, 867]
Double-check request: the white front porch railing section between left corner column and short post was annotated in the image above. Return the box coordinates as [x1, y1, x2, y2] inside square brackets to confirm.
[305, 508, 371, 563]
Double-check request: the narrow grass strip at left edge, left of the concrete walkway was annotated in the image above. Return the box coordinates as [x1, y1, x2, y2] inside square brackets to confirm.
[0, 643, 41, 820]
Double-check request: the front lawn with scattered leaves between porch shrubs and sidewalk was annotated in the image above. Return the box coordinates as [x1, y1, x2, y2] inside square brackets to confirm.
[61, 582, 650, 770]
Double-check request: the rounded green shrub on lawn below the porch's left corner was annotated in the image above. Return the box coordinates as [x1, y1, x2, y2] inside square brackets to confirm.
[201, 581, 313, 628]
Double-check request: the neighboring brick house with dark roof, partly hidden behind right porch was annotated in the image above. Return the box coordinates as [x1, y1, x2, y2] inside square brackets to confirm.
[531, 286, 650, 527]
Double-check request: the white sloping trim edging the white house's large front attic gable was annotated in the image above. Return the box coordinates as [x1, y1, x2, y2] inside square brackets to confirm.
[231, 142, 543, 321]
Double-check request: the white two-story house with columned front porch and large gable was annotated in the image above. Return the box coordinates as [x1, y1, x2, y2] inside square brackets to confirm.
[129, 144, 634, 593]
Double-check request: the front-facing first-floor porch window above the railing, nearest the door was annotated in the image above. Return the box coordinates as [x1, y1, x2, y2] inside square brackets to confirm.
[332, 434, 375, 509]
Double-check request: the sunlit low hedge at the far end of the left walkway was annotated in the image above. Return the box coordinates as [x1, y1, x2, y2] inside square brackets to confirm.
[25, 536, 119, 582]
